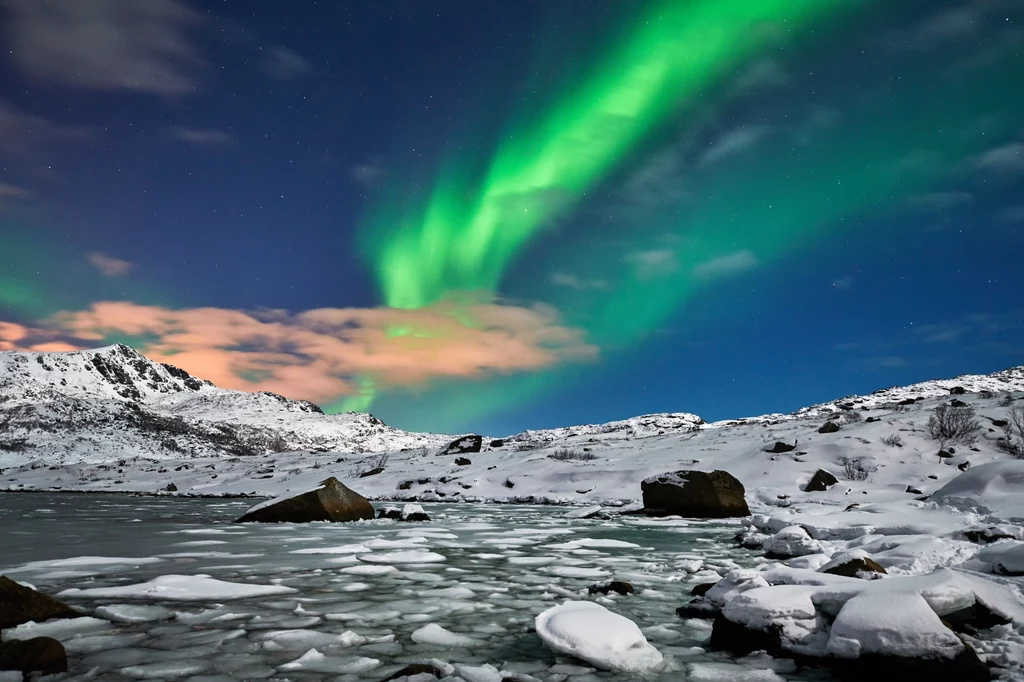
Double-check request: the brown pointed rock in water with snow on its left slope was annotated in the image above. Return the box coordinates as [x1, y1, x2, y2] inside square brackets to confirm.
[237, 476, 374, 523]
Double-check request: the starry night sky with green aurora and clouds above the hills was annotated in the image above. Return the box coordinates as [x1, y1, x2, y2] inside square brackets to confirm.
[0, 0, 1024, 434]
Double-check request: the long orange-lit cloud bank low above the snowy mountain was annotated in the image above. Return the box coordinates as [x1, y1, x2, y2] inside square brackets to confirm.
[18, 301, 597, 401]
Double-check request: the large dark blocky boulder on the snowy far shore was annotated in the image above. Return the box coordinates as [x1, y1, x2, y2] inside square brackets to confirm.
[640, 471, 751, 518]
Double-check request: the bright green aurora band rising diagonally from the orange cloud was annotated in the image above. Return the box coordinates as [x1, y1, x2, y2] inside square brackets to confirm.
[365, 0, 849, 308]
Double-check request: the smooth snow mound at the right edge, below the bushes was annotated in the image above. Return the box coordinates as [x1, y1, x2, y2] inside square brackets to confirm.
[932, 460, 1024, 520]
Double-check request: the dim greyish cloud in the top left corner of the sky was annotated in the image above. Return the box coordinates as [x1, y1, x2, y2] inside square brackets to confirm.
[6, 0, 201, 94]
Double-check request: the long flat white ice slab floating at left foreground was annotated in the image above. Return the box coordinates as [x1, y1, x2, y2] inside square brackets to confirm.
[57, 576, 297, 601]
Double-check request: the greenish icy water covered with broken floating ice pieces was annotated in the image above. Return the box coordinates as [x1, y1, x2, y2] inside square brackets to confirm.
[0, 494, 825, 682]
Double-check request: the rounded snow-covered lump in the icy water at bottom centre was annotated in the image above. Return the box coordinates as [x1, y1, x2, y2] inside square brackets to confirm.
[535, 601, 665, 674]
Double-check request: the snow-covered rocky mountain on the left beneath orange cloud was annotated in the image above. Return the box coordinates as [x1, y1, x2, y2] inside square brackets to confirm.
[0, 344, 451, 465]
